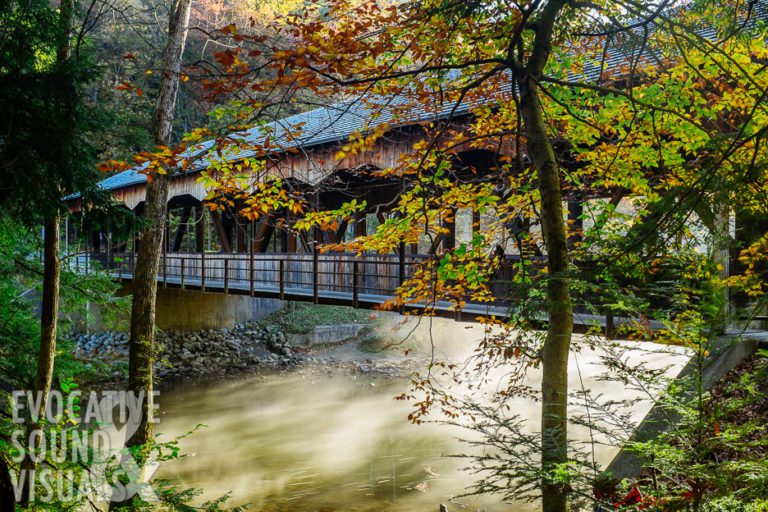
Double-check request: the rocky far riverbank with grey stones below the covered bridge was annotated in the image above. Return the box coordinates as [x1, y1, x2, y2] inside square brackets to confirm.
[75, 322, 418, 380]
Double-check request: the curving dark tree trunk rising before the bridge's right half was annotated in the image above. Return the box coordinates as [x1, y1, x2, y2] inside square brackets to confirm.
[515, 0, 573, 512]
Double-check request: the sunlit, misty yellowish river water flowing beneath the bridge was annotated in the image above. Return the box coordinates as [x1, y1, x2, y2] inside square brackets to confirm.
[155, 319, 687, 512]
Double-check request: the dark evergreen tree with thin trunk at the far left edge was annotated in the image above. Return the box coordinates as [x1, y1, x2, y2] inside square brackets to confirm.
[0, 0, 111, 500]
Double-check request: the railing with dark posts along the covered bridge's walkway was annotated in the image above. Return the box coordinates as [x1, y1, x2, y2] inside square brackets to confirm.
[74, 252, 512, 306]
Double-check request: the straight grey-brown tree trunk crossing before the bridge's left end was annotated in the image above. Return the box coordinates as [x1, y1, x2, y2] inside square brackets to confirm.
[128, 0, 192, 446]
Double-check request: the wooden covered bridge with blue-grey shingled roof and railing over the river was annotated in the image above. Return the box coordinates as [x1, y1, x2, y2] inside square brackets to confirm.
[66, 91, 604, 319]
